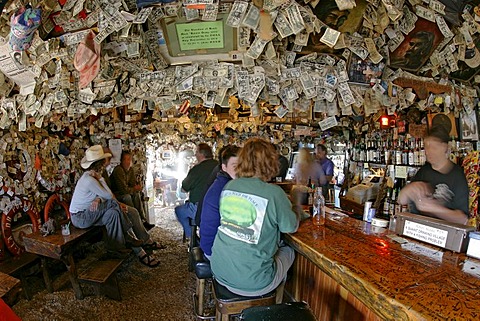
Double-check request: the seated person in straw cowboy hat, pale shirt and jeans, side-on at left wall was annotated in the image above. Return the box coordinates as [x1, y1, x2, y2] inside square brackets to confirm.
[70, 145, 160, 267]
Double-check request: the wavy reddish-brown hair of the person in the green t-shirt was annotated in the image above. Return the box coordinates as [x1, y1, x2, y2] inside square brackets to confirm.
[237, 137, 278, 181]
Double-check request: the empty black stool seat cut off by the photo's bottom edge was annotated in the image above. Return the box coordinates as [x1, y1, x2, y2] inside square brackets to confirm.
[240, 302, 317, 321]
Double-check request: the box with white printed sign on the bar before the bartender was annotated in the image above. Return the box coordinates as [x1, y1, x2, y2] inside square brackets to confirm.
[395, 213, 475, 253]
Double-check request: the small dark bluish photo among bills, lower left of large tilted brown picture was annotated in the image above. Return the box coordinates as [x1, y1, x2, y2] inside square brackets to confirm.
[347, 54, 385, 85]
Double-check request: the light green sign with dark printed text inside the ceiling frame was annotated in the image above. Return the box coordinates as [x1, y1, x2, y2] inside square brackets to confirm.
[175, 21, 224, 51]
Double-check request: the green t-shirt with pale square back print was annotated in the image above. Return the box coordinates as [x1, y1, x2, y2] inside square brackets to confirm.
[210, 178, 298, 292]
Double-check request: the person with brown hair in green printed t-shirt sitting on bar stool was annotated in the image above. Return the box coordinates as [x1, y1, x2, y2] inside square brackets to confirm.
[210, 138, 299, 297]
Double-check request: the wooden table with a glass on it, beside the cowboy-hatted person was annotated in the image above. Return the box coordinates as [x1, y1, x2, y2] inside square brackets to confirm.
[23, 225, 102, 299]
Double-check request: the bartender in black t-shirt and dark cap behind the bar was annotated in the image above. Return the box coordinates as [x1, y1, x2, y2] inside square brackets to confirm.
[398, 126, 469, 224]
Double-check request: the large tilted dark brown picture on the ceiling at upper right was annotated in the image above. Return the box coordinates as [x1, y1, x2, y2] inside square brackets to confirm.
[390, 18, 443, 71]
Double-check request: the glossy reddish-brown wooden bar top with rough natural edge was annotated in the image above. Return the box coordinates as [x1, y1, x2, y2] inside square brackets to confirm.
[285, 209, 480, 320]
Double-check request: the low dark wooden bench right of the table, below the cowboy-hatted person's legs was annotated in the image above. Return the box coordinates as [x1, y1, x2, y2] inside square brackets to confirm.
[78, 255, 125, 300]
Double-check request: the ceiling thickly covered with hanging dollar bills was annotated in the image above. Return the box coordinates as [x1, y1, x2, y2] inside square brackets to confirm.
[0, 0, 480, 137]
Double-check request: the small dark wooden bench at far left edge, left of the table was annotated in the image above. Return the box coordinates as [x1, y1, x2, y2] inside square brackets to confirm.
[0, 252, 40, 300]
